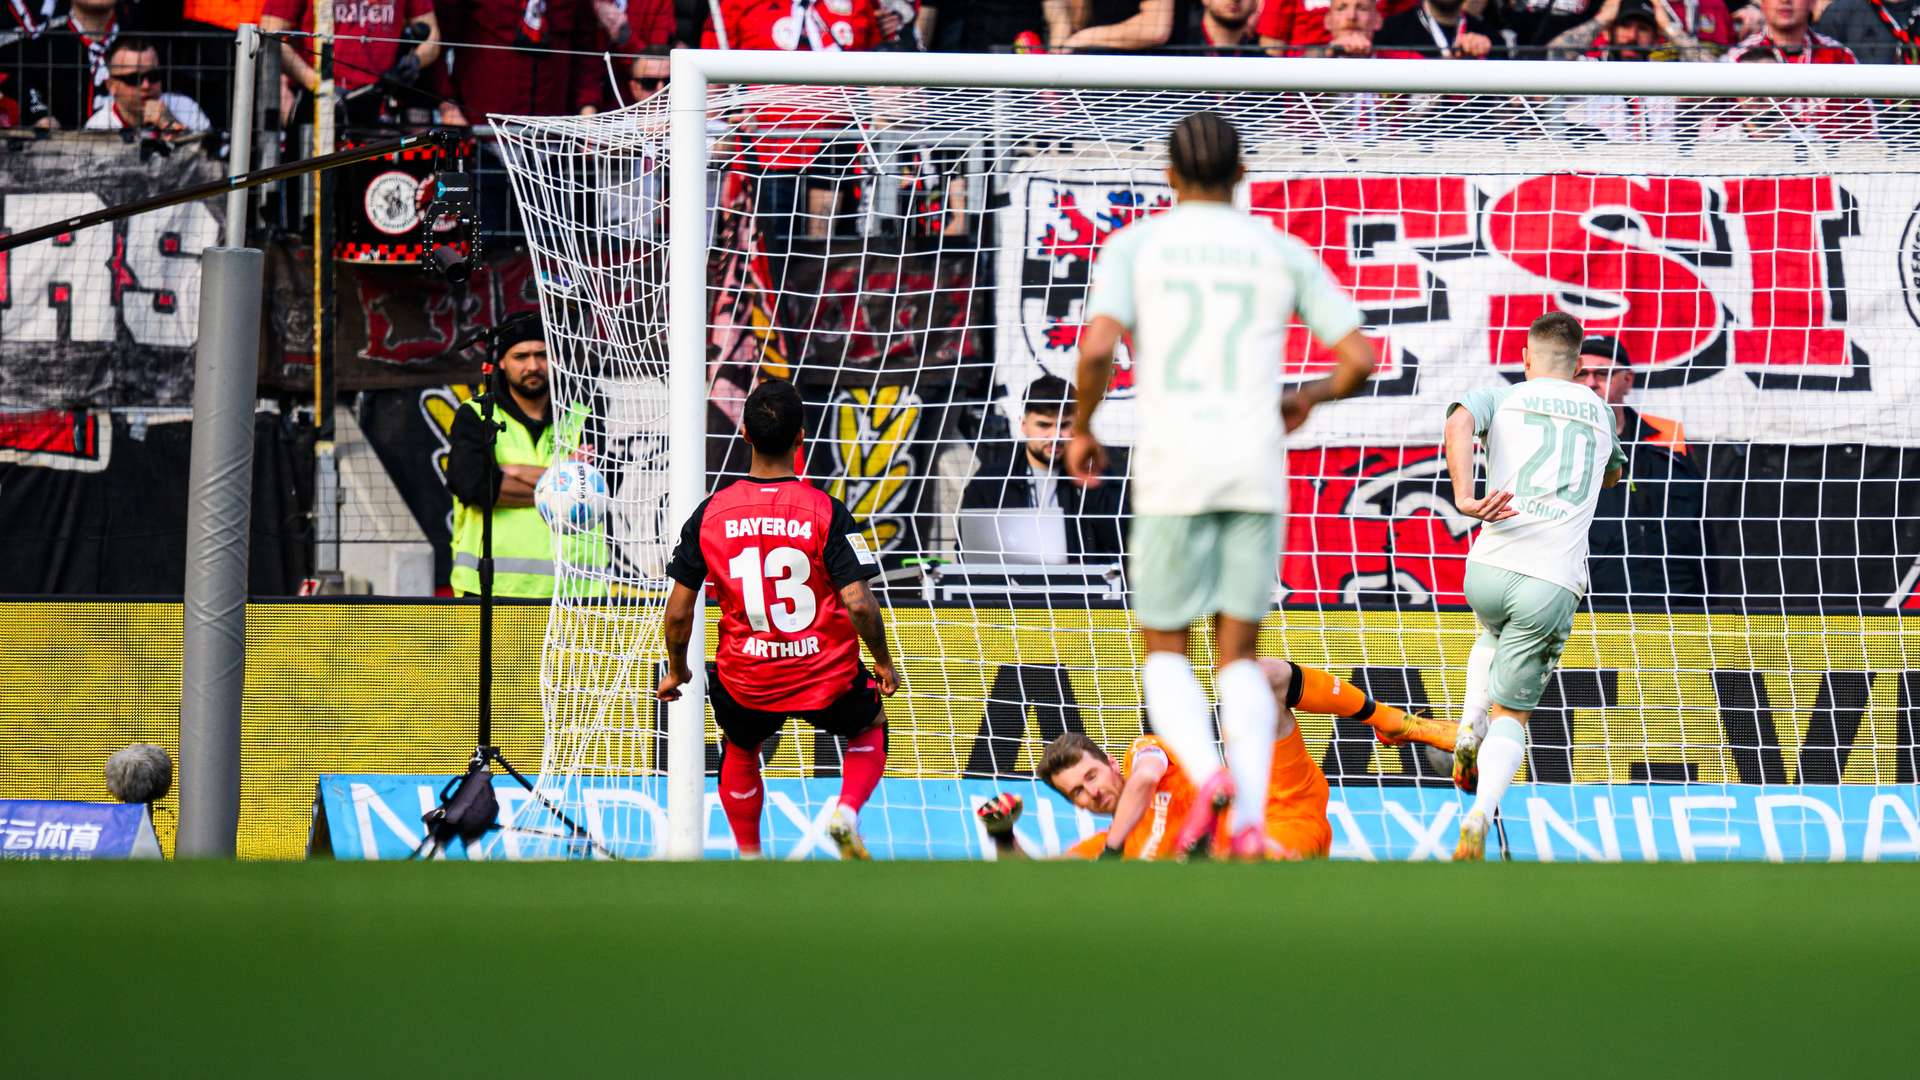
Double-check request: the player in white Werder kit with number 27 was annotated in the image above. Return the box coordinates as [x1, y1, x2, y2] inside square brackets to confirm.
[1068, 111, 1373, 859]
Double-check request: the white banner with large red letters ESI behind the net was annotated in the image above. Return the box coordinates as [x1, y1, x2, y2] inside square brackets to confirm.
[995, 148, 1920, 446]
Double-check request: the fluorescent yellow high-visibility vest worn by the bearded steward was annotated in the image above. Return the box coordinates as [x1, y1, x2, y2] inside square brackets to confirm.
[449, 400, 607, 600]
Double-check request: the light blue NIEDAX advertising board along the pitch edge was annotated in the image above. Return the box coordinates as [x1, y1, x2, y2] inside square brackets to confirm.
[315, 774, 1920, 863]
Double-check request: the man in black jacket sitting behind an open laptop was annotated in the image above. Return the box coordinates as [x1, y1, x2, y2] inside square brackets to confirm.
[960, 375, 1131, 563]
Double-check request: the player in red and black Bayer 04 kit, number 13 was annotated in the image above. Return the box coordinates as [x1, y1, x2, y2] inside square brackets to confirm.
[655, 380, 899, 859]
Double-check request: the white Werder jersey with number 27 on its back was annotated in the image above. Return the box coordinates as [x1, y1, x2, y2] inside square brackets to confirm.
[1087, 202, 1359, 515]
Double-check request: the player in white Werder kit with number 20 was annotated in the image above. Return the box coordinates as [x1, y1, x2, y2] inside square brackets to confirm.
[1446, 311, 1626, 861]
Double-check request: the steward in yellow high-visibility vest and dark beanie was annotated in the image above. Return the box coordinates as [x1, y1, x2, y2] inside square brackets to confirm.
[447, 319, 607, 600]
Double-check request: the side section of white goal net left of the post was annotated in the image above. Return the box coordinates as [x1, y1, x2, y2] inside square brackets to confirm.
[484, 110, 670, 857]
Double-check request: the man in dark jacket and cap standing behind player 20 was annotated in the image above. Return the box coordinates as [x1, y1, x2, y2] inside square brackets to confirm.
[1576, 334, 1707, 609]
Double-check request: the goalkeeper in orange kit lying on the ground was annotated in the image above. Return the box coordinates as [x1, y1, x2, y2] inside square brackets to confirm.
[979, 659, 1459, 859]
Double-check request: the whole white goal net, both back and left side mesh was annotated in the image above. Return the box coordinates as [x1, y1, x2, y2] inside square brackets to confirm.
[480, 77, 1920, 859]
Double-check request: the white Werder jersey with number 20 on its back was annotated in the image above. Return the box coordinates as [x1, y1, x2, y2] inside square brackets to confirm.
[1448, 379, 1626, 596]
